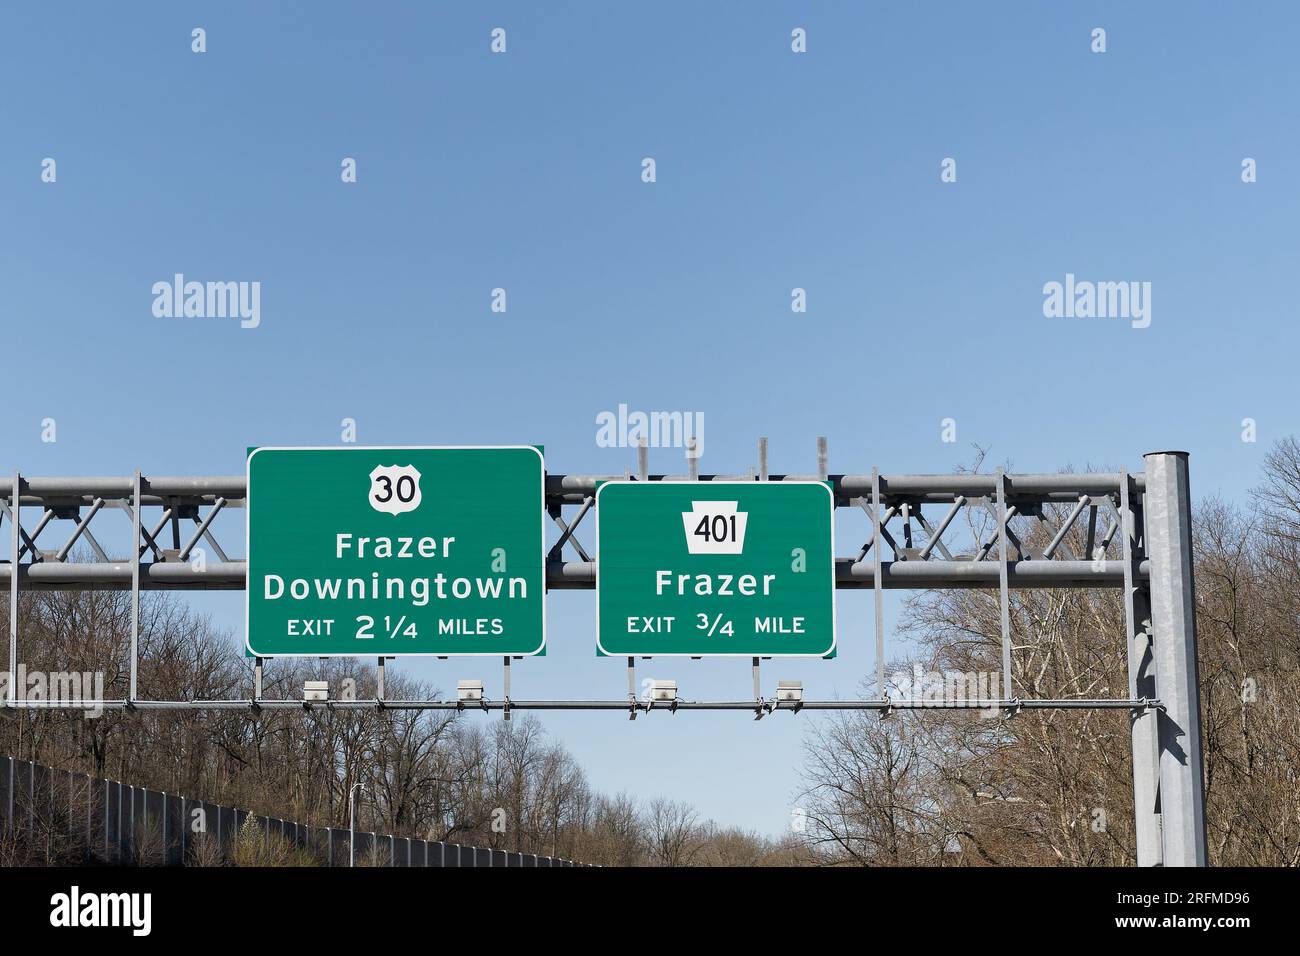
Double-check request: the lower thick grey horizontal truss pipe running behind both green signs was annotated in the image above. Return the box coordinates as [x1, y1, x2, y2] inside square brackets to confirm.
[0, 558, 1151, 591]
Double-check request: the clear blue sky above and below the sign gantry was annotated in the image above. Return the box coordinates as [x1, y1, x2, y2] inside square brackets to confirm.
[0, 1, 1300, 832]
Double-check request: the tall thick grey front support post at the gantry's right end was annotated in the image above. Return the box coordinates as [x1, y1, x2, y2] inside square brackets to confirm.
[1143, 451, 1206, 866]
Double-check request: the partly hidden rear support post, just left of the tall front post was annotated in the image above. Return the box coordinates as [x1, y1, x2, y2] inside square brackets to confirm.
[1123, 472, 1164, 866]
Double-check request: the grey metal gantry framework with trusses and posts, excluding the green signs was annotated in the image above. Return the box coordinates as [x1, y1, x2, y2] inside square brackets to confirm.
[0, 440, 1205, 865]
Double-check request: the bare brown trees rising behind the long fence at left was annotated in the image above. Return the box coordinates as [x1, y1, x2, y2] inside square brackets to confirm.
[0, 592, 801, 866]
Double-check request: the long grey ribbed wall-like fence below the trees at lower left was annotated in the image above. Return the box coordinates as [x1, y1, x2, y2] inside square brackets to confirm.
[0, 757, 581, 866]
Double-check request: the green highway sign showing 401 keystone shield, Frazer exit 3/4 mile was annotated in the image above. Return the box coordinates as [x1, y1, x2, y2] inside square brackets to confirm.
[595, 481, 835, 657]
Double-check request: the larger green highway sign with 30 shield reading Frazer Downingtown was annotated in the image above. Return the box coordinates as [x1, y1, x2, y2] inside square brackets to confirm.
[246, 446, 546, 657]
